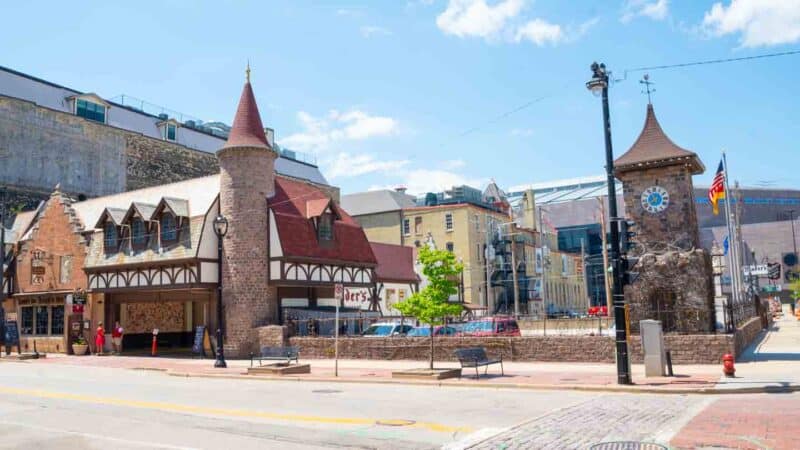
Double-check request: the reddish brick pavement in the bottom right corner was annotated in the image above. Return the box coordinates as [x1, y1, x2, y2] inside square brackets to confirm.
[671, 394, 800, 450]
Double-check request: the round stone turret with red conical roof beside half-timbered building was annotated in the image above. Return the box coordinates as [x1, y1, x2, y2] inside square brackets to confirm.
[217, 79, 278, 357]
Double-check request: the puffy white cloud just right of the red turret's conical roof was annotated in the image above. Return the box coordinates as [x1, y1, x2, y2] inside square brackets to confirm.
[279, 109, 399, 151]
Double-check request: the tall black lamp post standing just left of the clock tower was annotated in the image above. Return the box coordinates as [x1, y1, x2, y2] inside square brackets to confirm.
[586, 62, 631, 384]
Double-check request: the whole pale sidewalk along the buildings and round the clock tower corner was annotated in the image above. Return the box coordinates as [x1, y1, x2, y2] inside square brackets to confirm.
[6, 315, 800, 394]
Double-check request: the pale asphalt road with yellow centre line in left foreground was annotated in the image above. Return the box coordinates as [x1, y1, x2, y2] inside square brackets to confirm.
[0, 362, 591, 449]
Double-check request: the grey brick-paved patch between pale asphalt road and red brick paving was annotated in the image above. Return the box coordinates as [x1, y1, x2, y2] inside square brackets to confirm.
[469, 394, 708, 450]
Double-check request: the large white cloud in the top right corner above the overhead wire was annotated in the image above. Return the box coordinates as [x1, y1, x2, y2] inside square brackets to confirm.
[703, 0, 800, 47]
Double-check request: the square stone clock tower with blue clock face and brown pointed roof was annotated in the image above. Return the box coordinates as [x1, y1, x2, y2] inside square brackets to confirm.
[614, 104, 714, 332]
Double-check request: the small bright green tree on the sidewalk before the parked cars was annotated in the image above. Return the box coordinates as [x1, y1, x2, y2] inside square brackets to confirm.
[394, 246, 463, 370]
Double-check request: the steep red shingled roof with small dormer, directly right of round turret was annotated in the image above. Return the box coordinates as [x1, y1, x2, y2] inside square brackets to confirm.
[269, 177, 377, 264]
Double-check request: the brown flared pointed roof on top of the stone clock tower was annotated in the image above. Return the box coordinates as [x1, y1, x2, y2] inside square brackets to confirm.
[614, 104, 705, 174]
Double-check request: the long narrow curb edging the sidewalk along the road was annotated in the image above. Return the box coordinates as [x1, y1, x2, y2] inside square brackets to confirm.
[165, 369, 800, 395]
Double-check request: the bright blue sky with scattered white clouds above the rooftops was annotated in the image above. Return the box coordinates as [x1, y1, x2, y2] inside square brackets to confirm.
[0, 0, 800, 194]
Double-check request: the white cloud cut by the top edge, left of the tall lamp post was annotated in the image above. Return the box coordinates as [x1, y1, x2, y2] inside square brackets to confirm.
[436, 0, 524, 39]
